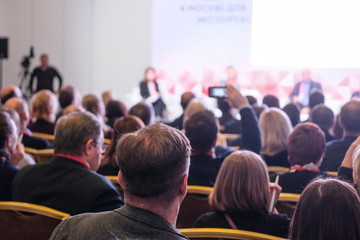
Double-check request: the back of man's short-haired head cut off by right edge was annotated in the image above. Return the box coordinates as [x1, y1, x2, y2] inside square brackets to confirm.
[340, 100, 360, 134]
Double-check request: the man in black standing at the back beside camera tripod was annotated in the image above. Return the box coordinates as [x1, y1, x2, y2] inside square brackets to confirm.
[29, 53, 62, 94]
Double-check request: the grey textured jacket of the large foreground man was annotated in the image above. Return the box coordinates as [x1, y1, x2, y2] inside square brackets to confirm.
[50, 204, 188, 240]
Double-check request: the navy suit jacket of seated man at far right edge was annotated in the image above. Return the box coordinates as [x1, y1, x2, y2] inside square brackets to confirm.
[320, 136, 356, 171]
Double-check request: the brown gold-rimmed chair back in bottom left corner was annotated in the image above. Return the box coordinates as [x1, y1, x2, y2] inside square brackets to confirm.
[0, 202, 70, 240]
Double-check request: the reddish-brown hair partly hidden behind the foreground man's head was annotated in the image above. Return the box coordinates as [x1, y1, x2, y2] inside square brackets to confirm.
[101, 115, 145, 167]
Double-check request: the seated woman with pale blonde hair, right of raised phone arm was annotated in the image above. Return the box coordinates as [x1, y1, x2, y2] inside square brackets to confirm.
[259, 108, 292, 167]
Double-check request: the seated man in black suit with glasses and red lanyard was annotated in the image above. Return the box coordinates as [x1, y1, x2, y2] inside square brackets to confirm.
[12, 112, 123, 215]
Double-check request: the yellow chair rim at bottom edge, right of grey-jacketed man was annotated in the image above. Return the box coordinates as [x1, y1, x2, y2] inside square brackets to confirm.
[179, 228, 285, 240]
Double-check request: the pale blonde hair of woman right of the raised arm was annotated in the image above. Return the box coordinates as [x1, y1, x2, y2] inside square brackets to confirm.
[259, 108, 292, 156]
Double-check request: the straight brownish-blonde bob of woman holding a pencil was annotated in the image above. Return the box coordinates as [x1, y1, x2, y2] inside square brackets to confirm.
[209, 151, 269, 215]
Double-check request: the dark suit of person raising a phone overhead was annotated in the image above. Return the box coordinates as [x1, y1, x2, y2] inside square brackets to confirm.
[188, 107, 261, 186]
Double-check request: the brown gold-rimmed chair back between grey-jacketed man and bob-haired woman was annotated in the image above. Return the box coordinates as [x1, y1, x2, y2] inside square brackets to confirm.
[176, 185, 212, 228]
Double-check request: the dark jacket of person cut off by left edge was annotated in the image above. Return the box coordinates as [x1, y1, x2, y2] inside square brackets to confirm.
[0, 151, 18, 201]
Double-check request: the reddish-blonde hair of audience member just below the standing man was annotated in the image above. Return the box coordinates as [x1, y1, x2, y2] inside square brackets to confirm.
[30, 90, 58, 122]
